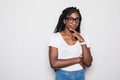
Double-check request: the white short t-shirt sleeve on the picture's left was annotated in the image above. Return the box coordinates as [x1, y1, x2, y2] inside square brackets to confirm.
[48, 33, 58, 48]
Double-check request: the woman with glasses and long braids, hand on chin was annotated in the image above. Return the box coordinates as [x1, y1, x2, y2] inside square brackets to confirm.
[49, 7, 92, 80]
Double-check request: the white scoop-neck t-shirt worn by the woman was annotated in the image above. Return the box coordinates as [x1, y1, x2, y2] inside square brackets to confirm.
[48, 32, 90, 71]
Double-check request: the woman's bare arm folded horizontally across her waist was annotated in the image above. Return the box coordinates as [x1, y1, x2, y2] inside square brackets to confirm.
[49, 46, 82, 69]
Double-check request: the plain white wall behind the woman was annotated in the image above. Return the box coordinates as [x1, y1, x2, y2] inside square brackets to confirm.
[0, 0, 120, 80]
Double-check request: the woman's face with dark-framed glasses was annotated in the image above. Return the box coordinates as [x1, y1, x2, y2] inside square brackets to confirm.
[63, 12, 79, 29]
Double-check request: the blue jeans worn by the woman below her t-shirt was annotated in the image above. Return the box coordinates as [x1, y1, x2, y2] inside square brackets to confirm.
[56, 69, 85, 80]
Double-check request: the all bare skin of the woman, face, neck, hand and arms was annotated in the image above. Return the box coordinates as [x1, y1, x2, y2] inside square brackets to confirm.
[49, 12, 92, 69]
